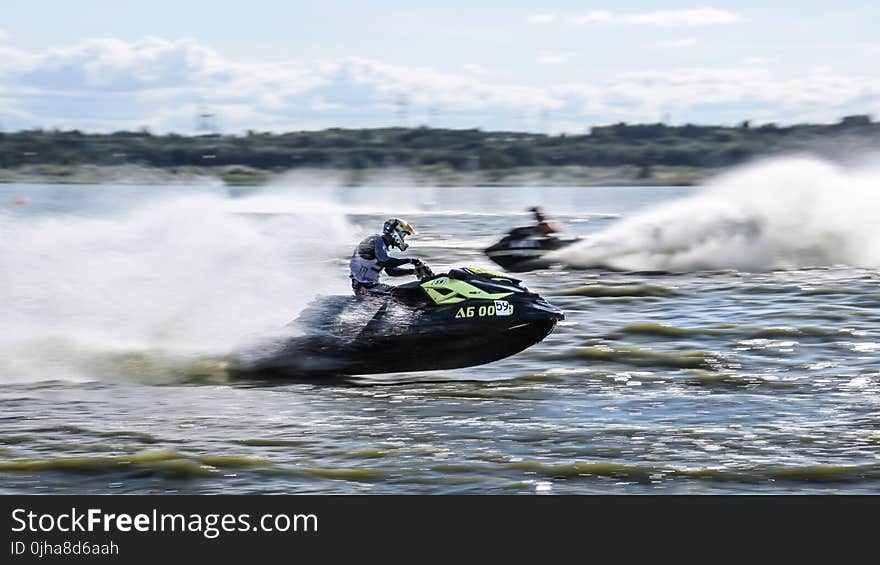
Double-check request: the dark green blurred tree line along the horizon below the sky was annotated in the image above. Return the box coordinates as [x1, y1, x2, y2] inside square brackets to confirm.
[0, 115, 880, 172]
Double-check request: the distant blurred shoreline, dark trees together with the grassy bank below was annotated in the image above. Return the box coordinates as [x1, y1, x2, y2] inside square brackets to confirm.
[0, 115, 880, 186]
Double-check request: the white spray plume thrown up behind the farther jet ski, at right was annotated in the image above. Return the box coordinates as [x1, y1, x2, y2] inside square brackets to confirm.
[559, 153, 880, 271]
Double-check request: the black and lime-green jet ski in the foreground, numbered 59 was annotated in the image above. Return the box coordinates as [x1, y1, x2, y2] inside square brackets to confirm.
[233, 265, 565, 379]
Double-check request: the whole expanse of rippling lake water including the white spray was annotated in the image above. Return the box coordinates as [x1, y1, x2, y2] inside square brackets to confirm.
[0, 156, 880, 494]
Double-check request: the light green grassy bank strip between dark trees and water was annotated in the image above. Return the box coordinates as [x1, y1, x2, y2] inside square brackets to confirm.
[0, 165, 719, 187]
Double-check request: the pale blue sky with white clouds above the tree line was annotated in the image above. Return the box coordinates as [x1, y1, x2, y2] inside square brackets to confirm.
[0, 0, 880, 134]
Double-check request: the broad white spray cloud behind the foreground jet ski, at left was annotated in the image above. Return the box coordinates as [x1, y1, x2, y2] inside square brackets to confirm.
[0, 189, 353, 378]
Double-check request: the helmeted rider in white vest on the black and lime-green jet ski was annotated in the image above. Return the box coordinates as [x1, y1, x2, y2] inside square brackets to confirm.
[349, 218, 422, 296]
